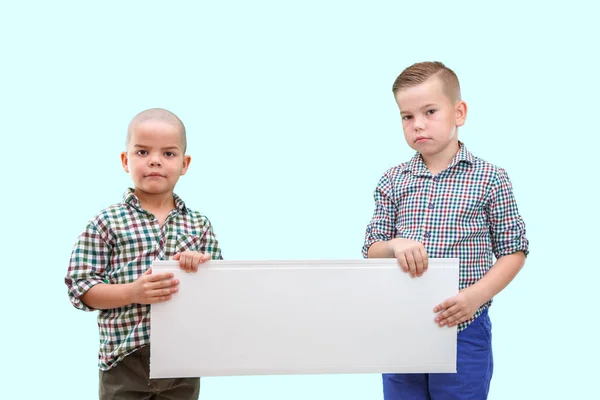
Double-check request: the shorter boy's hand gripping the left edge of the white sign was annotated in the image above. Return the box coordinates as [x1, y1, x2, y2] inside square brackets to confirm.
[131, 268, 179, 304]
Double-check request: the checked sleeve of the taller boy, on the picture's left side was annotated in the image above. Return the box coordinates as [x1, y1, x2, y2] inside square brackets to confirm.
[362, 174, 397, 258]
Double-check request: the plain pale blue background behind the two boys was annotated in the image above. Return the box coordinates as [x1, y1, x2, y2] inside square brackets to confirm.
[0, 1, 600, 400]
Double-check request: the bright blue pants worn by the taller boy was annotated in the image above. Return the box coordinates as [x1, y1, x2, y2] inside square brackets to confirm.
[383, 309, 494, 400]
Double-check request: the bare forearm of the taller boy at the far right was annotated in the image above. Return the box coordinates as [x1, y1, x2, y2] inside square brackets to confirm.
[465, 251, 525, 304]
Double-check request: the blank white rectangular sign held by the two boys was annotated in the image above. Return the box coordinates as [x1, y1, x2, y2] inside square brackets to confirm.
[150, 259, 458, 378]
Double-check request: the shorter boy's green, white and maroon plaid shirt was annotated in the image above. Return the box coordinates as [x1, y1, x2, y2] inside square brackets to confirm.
[65, 189, 222, 371]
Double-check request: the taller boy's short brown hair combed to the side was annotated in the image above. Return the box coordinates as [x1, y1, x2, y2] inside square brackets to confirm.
[392, 61, 461, 102]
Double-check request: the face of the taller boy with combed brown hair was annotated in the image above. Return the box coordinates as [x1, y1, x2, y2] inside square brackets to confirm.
[396, 76, 467, 157]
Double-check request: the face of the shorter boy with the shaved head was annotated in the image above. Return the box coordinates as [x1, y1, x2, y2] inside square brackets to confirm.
[121, 120, 191, 194]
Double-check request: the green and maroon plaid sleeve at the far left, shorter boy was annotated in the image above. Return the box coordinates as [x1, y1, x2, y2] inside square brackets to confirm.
[65, 222, 111, 311]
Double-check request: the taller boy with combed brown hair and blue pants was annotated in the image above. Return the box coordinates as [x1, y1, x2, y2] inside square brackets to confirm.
[362, 62, 529, 400]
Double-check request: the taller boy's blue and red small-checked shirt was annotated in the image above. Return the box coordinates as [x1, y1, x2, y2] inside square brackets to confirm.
[362, 143, 529, 331]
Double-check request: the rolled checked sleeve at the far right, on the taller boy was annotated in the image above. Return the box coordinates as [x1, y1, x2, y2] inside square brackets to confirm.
[487, 168, 529, 258]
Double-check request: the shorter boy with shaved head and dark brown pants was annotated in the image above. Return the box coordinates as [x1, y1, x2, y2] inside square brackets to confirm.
[65, 108, 222, 400]
